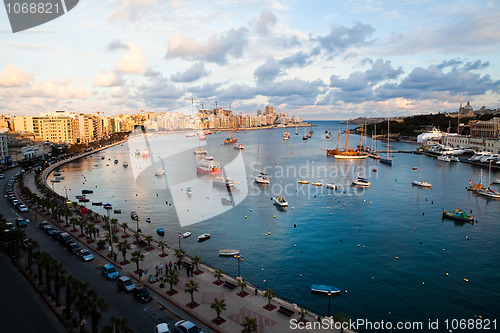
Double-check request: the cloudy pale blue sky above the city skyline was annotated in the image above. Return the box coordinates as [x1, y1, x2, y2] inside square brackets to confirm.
[0, 0, 500, 120]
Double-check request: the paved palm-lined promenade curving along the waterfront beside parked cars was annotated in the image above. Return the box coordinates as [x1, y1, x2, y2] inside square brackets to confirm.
[20, 152, 347, 333]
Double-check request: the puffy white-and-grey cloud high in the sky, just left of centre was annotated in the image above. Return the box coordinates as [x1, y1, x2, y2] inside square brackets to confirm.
[165, 27, 248, 65]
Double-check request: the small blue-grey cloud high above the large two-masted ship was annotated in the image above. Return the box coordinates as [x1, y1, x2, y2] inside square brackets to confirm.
[316, 22, 375, 52]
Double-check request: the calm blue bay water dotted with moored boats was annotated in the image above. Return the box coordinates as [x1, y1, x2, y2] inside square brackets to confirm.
[49, 122, 500, 331]
